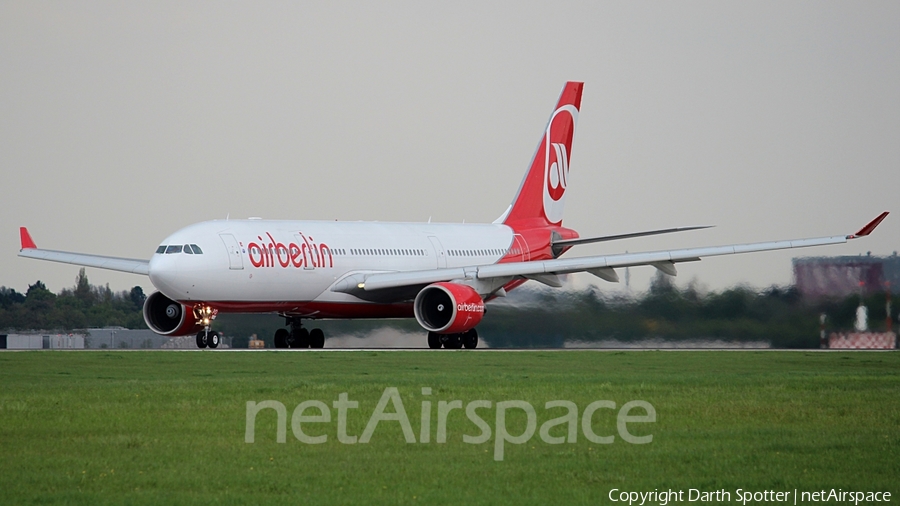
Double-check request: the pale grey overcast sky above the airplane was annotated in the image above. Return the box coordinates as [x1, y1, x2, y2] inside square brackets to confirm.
[0, 1, 900, 293]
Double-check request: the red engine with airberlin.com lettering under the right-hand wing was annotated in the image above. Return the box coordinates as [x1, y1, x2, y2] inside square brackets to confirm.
[413, 283, 484, 334]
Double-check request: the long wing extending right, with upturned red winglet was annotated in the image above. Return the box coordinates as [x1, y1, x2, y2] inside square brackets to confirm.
[332, 212, 888, 293]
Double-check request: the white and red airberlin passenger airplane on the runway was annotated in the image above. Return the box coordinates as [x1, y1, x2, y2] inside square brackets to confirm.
[19, 81, 888, 349]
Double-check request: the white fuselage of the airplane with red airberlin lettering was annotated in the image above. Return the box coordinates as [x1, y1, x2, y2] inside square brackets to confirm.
[149, 219, 527, 316]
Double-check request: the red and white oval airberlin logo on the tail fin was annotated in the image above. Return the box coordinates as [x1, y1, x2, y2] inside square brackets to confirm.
[544, 104, 578, 223]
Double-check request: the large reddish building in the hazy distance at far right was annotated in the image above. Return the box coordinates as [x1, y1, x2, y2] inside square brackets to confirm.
[793, 251, 900, 299]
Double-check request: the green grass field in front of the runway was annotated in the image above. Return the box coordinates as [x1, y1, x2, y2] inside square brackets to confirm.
[0, 351, 900, 504]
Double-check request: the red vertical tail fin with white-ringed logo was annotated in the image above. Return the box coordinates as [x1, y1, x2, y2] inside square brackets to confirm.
[498, 81, 584, 228]
